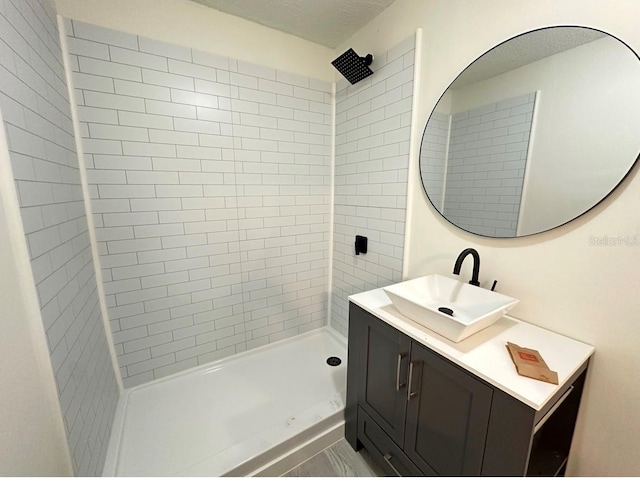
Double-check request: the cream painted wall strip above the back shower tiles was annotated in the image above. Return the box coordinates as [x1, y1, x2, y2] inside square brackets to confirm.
[56, 0, 335, 81]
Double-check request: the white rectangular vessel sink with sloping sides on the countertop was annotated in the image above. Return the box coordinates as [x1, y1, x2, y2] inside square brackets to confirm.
[384, 274, 520, 342]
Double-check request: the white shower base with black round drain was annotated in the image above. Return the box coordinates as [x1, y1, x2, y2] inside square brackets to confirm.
[103, 328, 347, 476]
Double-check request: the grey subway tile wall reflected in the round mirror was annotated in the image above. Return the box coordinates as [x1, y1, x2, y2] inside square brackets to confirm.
[444, 92, 536, 237]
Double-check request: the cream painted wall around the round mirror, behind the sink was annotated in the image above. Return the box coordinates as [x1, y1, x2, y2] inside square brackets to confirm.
[343, 0, 640, 476]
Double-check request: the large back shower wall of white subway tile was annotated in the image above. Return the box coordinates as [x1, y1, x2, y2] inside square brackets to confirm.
[67, 21, 332, 386]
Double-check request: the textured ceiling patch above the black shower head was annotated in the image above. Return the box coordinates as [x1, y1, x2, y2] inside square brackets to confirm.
[193, 0, 394, 48]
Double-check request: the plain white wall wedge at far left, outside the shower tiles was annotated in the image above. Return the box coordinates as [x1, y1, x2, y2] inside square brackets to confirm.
[0, 110, 73, 476]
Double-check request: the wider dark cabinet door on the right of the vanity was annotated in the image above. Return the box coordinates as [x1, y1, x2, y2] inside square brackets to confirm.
[404, 342, 493, 476]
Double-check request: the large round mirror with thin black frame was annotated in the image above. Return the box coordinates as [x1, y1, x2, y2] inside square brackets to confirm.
[420, 27, 640, 237]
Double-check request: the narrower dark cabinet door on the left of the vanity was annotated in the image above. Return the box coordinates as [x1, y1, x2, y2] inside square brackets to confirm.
[356, 310, 411, 446]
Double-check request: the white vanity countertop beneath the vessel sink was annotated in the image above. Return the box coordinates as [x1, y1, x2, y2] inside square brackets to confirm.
[349, 289, 594, 410]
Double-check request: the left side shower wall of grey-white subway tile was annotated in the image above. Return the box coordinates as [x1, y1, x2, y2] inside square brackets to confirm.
[0, 0, 119, 476]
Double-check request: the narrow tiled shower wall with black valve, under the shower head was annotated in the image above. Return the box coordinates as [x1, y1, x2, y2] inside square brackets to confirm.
[331, 36, 415, 336]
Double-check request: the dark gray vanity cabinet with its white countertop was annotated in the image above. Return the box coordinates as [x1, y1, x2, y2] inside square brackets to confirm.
[346, 289, 593, 476]
